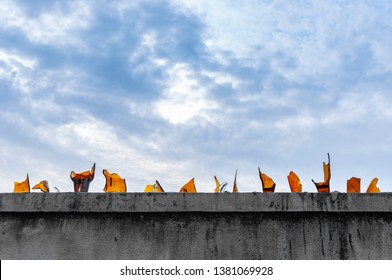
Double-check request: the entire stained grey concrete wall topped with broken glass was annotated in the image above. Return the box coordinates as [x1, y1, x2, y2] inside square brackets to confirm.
[0, 193, 392, 259]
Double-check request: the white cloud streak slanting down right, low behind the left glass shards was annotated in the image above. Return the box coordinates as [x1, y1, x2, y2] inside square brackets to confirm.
[36, 112, 191, 192]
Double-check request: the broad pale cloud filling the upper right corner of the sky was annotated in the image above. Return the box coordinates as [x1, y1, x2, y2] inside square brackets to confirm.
[172, 0, 392, 82]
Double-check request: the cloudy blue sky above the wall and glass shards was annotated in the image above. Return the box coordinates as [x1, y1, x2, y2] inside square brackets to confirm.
[0, 0, 392, 192]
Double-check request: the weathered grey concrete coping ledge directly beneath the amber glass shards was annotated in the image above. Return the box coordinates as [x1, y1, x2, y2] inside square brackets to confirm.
[0, 192, 392, 213]
